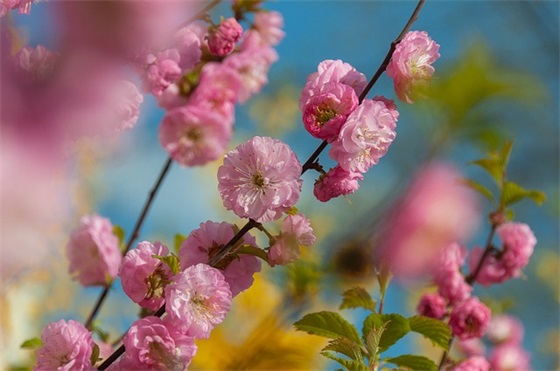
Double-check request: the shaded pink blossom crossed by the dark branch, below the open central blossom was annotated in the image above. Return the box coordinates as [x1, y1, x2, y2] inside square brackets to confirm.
[179, 221, 261, 296]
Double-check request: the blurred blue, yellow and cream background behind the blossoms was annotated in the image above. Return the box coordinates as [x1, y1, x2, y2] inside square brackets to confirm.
[0, 1, 560, 370]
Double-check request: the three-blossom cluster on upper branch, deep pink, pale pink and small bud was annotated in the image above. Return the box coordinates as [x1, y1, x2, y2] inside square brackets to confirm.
[299, 60, 398, 202]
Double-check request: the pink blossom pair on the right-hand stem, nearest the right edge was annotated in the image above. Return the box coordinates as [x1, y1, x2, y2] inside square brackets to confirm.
[469, 222, 537, 286]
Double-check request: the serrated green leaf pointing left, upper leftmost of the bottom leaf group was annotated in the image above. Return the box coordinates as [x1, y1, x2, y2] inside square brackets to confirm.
[294, 311, 361, 344]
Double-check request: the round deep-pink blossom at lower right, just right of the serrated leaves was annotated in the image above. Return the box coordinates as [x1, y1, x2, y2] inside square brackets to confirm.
[449, 296, 490, 340]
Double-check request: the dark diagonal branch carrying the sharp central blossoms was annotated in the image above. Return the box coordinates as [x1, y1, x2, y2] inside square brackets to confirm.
[98, 0, 425, 370]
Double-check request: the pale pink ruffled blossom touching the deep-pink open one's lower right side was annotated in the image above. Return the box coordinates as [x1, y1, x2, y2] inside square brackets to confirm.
[329, 100, 396, 173]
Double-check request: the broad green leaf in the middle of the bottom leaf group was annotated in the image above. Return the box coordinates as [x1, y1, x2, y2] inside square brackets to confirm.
[362, 313, 410, 353]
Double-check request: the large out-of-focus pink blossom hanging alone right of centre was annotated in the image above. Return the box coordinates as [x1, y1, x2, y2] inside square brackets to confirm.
[375, 162, 480, 279]
